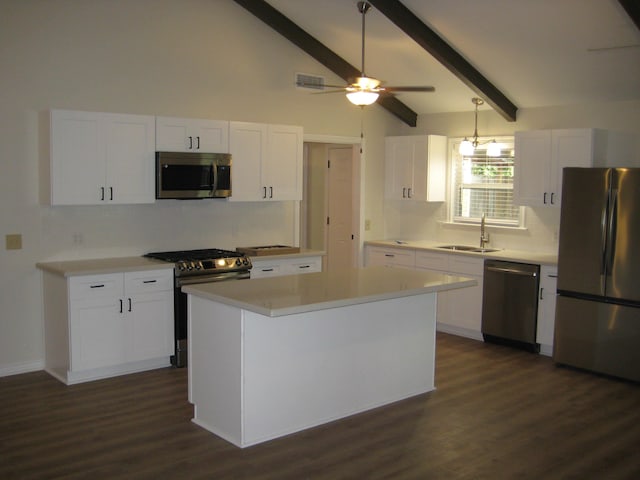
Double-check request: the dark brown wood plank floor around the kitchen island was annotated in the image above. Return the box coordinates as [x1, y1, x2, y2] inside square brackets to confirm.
[0, 334, 640, 480]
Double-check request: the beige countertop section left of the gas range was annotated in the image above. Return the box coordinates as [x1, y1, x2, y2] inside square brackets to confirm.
[36, 257, 173, 277]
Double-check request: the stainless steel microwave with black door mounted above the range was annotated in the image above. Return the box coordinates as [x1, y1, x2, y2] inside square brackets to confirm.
[156, 152, 231, 200]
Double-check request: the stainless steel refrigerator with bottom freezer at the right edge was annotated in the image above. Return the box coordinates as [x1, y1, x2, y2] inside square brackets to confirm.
[553, 168, 640, 382]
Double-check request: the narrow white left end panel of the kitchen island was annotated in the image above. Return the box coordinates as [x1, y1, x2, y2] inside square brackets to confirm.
[187, 295, 243, 445]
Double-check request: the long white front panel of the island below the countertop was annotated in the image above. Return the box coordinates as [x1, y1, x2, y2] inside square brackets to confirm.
[242, 293, 436, 446]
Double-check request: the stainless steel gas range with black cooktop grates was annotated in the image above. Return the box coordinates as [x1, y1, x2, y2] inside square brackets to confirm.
[145, 248, 251, 367]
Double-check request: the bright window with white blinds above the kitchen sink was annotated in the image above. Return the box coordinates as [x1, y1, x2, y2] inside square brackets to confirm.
[450, 137, 522, 227]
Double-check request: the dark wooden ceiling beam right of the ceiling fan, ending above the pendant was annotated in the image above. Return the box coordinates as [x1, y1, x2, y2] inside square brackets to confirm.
[368, 0, 516, 122]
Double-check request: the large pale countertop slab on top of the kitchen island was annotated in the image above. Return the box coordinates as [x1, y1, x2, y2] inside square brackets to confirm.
[182, 267, 477, 317]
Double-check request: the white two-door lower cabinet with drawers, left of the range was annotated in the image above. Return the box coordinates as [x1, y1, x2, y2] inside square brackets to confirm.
[43, 269, 173, 384]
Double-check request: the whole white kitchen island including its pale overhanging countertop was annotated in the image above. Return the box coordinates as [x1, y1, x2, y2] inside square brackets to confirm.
[183, 267, 475, 447]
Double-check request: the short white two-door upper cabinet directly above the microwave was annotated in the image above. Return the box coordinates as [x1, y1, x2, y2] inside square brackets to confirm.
[156, 117, 229, 153]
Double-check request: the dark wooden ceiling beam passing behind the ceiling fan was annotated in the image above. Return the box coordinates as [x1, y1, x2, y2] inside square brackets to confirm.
[234, 0, 418, 127]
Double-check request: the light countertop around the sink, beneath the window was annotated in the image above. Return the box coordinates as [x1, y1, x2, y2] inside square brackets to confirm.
[364, 240, 558, 266]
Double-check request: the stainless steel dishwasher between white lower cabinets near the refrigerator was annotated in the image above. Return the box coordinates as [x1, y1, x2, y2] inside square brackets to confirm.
[482, 259, 540, 352]
